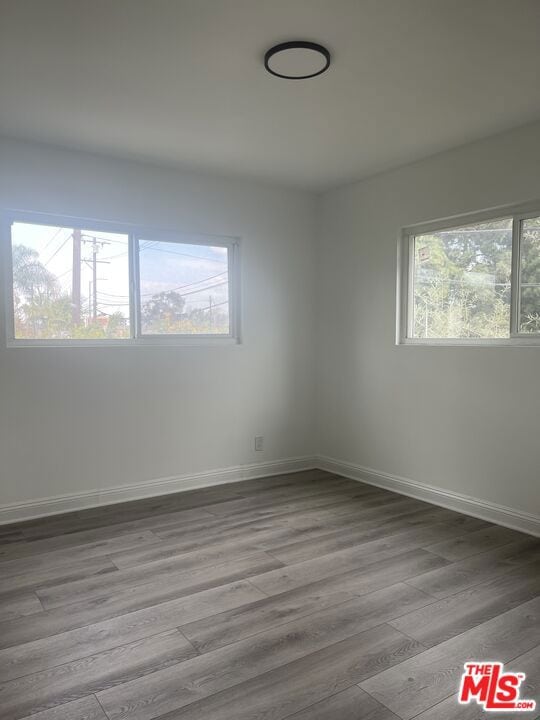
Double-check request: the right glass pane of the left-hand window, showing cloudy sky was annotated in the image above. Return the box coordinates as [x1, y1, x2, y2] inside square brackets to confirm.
[139, 240, 230, 335]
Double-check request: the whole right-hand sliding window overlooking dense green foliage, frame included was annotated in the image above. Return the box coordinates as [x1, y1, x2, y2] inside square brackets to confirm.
[400, 208, 540, 345]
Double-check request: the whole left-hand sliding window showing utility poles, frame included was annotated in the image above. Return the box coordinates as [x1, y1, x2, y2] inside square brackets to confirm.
[2, 211, 238, 345]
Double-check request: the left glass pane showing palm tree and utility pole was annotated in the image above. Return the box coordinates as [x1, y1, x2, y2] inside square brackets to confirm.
[11, 222, 130, 340]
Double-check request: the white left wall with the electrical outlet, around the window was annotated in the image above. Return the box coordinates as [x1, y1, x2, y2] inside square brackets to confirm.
[0, 141, 315, 505]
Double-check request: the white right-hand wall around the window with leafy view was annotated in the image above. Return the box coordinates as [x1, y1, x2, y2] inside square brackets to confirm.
[317, 124, 540, 513]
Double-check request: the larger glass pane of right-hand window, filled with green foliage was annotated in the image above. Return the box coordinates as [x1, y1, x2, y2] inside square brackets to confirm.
[413, 219, 512, 339]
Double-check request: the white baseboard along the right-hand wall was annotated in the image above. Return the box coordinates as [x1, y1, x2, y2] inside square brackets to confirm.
[317, 457, 540, 537]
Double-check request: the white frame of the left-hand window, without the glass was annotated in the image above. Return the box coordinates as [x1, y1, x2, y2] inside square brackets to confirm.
[0, 211, 241, 348]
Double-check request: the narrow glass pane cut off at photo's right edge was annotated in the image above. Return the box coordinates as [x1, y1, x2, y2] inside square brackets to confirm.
[519, 217, 540, 333]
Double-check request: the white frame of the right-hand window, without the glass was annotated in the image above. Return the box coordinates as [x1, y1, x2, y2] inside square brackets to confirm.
[396, 201, 540, 347]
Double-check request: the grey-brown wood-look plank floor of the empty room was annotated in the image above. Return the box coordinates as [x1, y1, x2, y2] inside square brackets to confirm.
[0, 471, 540, 720]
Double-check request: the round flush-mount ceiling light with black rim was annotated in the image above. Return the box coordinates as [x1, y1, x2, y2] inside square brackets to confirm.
[264, 40, 330, 80]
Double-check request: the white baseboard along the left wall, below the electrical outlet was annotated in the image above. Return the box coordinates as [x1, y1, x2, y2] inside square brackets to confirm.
[0, 456, 317, 525]
